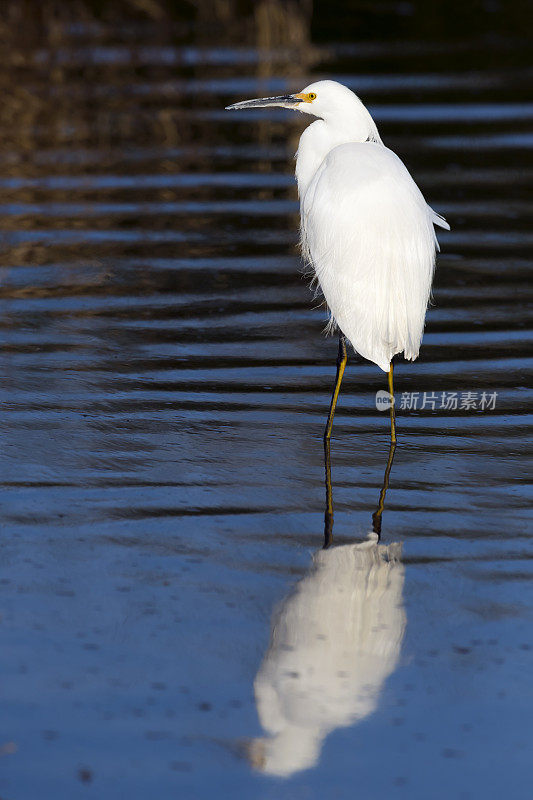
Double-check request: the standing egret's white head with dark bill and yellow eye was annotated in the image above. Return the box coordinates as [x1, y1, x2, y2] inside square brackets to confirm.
[226, 81, 379, 141]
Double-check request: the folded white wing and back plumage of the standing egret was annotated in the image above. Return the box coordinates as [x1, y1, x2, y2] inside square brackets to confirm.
[301, 142, 447, 371]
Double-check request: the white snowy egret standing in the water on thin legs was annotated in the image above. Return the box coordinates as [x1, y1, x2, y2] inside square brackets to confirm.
[227, 80, 450, 443]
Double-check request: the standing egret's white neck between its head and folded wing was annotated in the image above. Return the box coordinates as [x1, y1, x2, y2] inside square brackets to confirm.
[296, 108, 382, 201]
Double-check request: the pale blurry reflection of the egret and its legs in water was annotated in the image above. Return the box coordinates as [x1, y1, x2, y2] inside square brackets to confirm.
[248, 443, 406, 777]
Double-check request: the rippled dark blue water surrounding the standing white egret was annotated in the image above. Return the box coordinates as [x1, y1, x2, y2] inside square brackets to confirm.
[0, 4, 533, 800]
